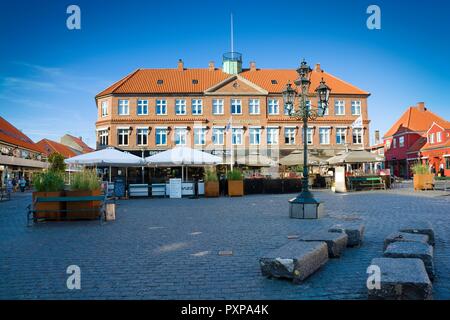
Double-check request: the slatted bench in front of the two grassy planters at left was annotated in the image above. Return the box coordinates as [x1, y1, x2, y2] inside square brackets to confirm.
[27, 195, 106, 225]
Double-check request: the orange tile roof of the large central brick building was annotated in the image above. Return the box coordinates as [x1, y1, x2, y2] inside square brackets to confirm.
[96, 64, 369, 98]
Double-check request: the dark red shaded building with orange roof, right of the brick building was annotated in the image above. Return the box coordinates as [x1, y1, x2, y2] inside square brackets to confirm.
[383, 102, 448, 178]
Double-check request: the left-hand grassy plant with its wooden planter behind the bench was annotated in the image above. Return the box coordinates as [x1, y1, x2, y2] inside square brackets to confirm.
[33, 170, 65, 220]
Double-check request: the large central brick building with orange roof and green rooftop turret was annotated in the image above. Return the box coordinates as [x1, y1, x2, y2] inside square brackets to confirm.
[95, 53, 370, 162]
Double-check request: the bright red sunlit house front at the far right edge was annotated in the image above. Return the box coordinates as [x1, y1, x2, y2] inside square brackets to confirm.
[420, 121, 450, 176]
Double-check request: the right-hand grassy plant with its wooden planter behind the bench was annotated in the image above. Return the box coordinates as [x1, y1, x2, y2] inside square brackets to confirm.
[66, 170, 102, 219]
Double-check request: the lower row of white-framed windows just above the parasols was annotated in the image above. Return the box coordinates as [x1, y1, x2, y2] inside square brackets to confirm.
[99, 127, 363, 146]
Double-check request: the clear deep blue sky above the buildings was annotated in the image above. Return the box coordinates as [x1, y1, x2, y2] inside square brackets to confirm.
[0, 0, 450, 146]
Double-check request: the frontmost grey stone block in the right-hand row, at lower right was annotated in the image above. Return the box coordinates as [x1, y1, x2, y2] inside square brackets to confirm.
[368, 258, 433, 300]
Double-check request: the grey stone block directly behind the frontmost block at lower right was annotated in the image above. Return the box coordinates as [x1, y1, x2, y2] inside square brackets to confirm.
[384, 242, 435, 281]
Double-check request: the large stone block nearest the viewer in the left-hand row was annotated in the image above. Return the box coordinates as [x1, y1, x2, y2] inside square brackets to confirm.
[259, 241, 328, 283]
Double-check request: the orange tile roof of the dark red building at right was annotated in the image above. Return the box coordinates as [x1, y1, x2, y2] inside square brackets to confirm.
[384, 107, 449, 138]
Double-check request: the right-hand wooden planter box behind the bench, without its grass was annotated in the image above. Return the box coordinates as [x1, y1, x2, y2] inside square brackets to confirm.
[66, 189, 102, 220]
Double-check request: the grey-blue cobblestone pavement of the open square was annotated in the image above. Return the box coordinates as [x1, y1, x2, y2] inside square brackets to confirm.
[0, 189, 450, 299]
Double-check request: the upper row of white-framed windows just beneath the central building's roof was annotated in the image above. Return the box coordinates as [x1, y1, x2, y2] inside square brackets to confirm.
[101, 99, 361, 117]
